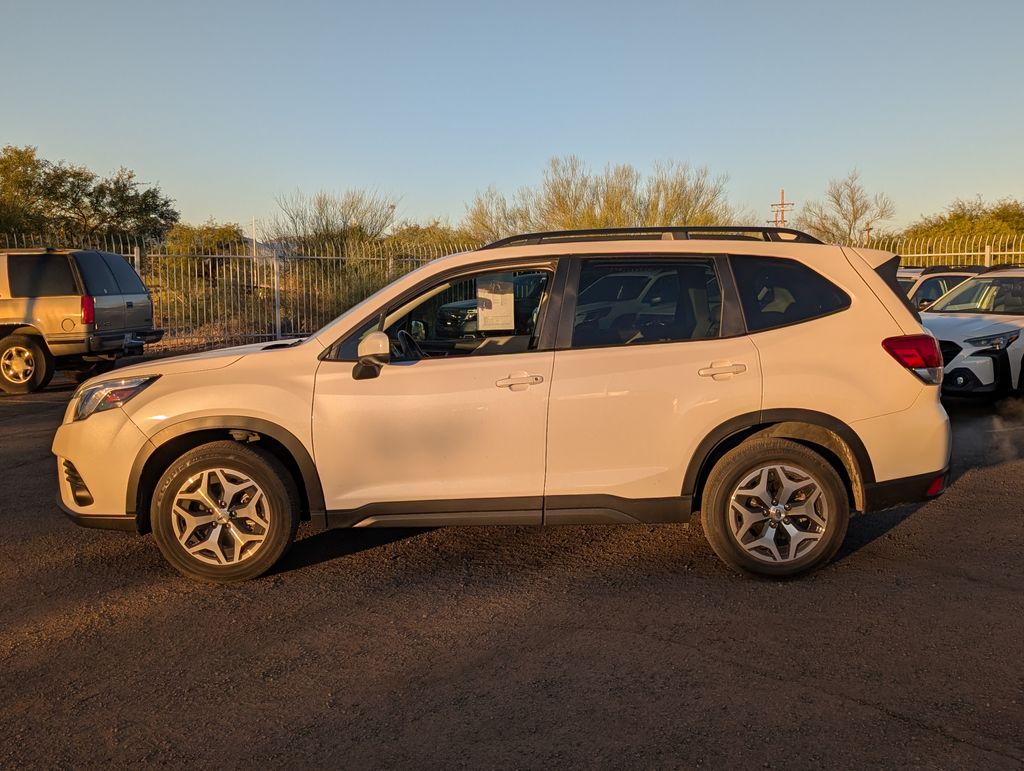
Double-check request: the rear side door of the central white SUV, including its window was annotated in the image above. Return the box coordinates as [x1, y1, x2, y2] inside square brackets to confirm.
[545, 255, 761, 522]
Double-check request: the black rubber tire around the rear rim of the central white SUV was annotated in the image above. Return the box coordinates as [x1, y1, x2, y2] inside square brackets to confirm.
[700, 438, 850, 577]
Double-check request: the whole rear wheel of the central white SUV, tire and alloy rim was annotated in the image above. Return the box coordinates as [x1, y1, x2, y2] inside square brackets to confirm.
[701, 438, 850, 577]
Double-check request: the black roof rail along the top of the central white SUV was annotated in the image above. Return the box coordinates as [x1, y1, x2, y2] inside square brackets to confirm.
[481, 225, 822, 249]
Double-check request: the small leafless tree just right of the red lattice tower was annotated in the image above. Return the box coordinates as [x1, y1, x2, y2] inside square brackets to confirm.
[795, 169, 896, 244]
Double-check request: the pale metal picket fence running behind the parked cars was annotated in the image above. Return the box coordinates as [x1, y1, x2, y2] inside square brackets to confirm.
[6, 228, 1024, 351]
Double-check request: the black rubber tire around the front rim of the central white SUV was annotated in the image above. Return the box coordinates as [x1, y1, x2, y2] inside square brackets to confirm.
[150, 441, 299, 583]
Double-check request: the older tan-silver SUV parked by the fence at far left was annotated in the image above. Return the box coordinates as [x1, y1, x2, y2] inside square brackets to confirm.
[0, 249, 163, 393]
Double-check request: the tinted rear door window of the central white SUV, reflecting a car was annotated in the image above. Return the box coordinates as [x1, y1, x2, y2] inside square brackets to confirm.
[572, 259, 722, 348]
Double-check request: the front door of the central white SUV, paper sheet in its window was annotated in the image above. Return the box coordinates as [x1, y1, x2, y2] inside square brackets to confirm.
[312, 262, 555, 524]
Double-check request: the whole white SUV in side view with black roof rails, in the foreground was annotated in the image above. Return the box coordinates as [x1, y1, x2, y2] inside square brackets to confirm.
[53, 227, 950, 581]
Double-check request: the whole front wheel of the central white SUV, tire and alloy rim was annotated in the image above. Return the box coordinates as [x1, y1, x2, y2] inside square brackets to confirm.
[151, 441, 299, 583]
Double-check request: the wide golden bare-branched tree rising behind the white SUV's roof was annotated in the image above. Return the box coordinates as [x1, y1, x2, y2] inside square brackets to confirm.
[462, 156, 736, 241]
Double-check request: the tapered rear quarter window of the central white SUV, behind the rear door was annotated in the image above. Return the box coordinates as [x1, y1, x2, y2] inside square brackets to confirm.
[730, 256, 850, 332]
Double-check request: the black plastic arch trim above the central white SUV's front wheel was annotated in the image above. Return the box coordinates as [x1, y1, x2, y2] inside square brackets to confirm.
[125, 415, 325, 517]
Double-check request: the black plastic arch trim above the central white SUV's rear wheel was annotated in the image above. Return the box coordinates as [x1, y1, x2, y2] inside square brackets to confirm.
[682, 409, 874, 511]
